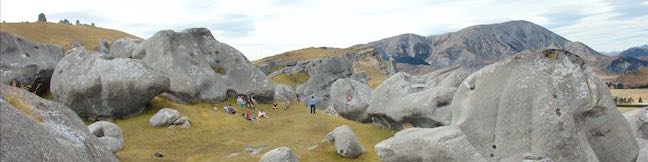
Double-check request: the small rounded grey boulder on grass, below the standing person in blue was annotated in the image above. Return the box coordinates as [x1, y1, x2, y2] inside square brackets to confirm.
[326, 125, 364, 158]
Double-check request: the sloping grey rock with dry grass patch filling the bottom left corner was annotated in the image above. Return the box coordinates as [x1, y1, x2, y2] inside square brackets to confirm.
[0, 84, 117, 162]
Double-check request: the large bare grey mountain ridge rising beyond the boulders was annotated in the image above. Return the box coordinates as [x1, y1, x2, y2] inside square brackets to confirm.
[367, 20, 606, 67]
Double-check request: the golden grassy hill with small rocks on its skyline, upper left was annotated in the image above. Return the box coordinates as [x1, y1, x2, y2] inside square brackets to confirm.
[0, 23, 139, 50]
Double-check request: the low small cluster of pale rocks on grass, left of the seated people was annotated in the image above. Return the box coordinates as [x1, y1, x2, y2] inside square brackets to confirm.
[149, 108, 191, 129]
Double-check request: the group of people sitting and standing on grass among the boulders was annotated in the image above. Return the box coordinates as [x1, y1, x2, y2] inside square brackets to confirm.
[214, 92, 353, 120]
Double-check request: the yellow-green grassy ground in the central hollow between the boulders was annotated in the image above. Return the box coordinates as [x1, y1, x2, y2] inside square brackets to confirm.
[115, 98, 393, 162]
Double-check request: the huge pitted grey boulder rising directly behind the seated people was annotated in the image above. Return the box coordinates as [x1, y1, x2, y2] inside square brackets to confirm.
[133, 28, 275, 102]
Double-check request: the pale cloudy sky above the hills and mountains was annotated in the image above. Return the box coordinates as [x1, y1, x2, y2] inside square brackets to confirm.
[0, 0, 648, 60]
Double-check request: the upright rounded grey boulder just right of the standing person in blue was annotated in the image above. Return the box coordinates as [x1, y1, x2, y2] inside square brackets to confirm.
[330, 78, 373, 122]
